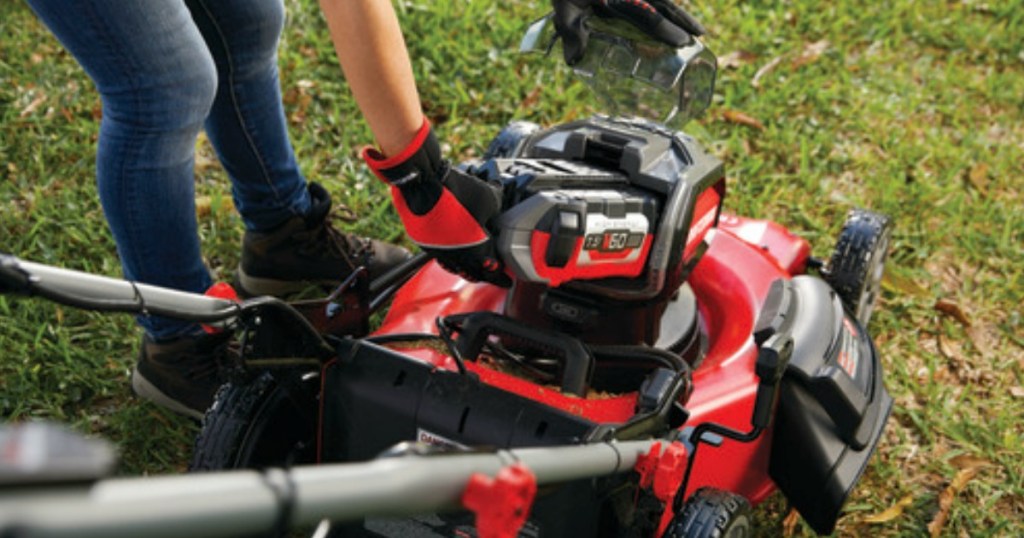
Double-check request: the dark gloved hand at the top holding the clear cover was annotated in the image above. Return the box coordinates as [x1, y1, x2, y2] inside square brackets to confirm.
[551, 0, 706, 66]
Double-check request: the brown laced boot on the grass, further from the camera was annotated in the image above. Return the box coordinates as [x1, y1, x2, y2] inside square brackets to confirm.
[238, 183, 410, 296]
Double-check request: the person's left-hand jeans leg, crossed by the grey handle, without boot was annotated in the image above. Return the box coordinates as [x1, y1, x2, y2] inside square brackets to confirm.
[29, 0, 217, 339]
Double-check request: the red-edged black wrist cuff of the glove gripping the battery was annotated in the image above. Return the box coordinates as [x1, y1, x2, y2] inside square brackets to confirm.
[362, 118, 442, 187]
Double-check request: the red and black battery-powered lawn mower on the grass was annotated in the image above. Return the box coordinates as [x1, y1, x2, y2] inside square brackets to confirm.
[0, 11, 892, 537]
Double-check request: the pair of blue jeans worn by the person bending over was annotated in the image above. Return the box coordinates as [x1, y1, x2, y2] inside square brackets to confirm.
[28, 0, 310, 339]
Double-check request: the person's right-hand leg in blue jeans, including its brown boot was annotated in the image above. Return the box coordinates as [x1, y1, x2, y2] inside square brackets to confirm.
[185, 0, 409, 295]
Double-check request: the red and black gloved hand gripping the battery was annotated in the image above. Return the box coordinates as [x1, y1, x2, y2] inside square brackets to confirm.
[362, 120, 512, 287]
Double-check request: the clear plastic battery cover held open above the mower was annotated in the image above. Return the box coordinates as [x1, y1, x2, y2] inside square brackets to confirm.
[519, 14, 718, 127]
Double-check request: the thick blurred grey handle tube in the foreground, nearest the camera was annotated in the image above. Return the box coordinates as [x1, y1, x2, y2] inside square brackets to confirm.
[0, 440, 658, 538]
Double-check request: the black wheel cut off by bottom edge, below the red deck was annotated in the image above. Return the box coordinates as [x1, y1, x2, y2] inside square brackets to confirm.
[665, 488, 753, 538]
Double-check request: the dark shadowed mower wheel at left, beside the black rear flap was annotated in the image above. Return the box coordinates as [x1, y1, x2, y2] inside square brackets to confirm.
[190, 370, 319, 470]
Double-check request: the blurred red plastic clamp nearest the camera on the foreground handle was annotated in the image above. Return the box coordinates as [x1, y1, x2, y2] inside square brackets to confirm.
[462, 463, 537, 538]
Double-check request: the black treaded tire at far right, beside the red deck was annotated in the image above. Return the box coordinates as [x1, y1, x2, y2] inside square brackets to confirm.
[824, 209, 892, 327]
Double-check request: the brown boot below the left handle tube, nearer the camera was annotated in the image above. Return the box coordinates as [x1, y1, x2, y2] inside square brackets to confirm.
[131, 332, 231, 419]
